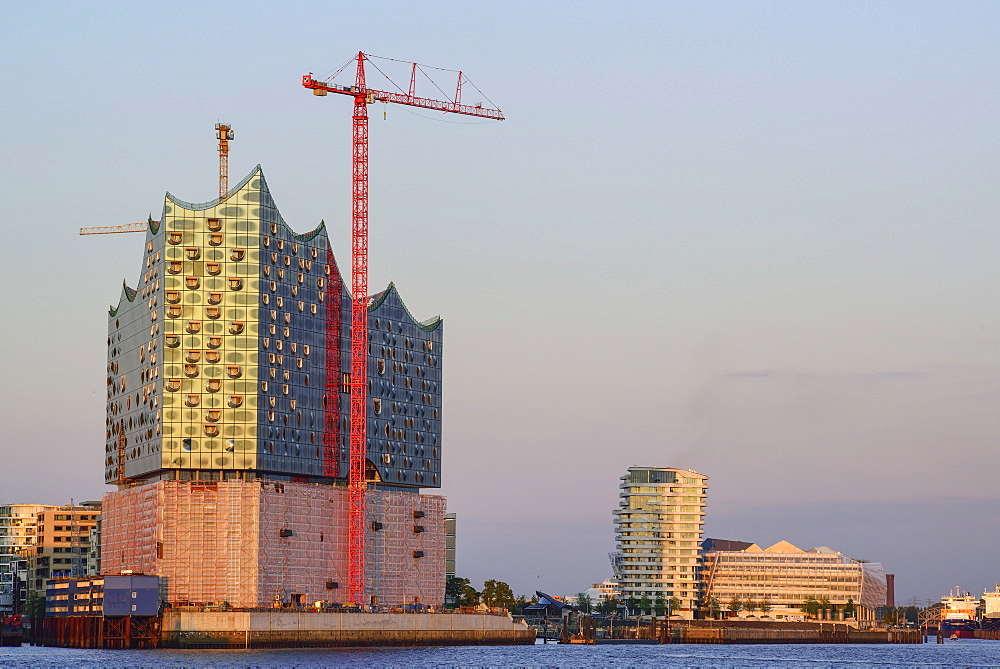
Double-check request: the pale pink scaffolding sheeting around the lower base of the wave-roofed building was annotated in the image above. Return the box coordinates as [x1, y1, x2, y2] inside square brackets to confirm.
[102, 481, 446, 608]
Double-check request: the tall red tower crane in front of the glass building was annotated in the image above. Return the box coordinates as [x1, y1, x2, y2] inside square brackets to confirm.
[302, 51, 504, 604]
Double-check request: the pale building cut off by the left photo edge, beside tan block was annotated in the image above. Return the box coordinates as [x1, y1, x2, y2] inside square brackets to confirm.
[0, 504, 56, 614]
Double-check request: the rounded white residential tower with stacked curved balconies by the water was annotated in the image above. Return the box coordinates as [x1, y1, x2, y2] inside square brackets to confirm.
[612, 467, 708, 618]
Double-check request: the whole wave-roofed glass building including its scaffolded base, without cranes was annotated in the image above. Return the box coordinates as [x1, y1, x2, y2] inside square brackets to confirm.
[100, 167, 446, 607]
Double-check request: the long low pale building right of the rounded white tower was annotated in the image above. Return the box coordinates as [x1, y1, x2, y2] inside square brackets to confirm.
[703, 539, 886, 620]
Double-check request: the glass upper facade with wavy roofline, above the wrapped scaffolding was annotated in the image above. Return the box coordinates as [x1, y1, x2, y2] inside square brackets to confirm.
[105, 167, 443, 488]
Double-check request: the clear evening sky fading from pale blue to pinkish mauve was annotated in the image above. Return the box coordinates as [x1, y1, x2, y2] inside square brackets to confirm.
[0, 0, 1000, 602]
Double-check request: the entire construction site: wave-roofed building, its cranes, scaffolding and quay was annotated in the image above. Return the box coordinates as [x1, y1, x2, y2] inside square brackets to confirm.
[42, 52, 534, 647]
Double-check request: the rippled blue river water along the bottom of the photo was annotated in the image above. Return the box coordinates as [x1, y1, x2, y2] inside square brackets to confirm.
[0, 637, 1000, 669]
